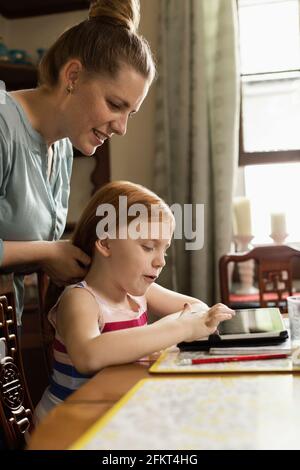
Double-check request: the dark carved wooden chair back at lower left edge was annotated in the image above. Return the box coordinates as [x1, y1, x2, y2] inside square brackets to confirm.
[0, 276, 33, 449]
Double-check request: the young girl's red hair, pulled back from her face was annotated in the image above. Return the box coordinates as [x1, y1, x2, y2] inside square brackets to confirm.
[72, 181, 174, 256]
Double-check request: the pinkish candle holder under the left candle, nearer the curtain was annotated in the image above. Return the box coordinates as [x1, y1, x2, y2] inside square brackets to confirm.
[234, 235, 259, 295]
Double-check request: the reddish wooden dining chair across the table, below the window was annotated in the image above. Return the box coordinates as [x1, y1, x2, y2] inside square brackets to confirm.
[219, 245, 300, 312]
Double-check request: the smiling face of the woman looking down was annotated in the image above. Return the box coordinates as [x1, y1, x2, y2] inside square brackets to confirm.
[63, 65, 149, 155]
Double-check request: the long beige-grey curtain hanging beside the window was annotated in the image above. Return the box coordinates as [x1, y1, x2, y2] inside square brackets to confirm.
[154, 0, 239, 303]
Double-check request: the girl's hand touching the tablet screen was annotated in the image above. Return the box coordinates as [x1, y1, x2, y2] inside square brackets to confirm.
[179, 303, 235, 341]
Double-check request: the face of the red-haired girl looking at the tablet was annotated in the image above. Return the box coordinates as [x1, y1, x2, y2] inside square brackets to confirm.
[109, 220, 174, 296]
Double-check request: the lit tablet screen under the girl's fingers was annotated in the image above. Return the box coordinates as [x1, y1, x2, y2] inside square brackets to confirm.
[218, 308, 285, 336]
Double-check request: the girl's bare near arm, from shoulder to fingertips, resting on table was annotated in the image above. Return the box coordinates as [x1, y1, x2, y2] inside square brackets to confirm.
[57, 289, 232, 374]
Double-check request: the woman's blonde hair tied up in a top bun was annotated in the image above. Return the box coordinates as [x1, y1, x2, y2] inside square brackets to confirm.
[39, 0, 156, 87]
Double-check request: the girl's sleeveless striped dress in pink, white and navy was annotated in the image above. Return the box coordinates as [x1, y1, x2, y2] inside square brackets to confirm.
[35, 281, 147, 423]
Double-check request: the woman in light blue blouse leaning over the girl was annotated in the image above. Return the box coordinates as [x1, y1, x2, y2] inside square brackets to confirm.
[0, 0, 155, 323]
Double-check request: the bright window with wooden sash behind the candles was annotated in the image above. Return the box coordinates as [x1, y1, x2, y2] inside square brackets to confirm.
[238, 0, 300, 244]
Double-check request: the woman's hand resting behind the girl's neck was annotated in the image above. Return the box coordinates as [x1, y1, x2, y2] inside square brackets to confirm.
[42, 240, 91, 286]
